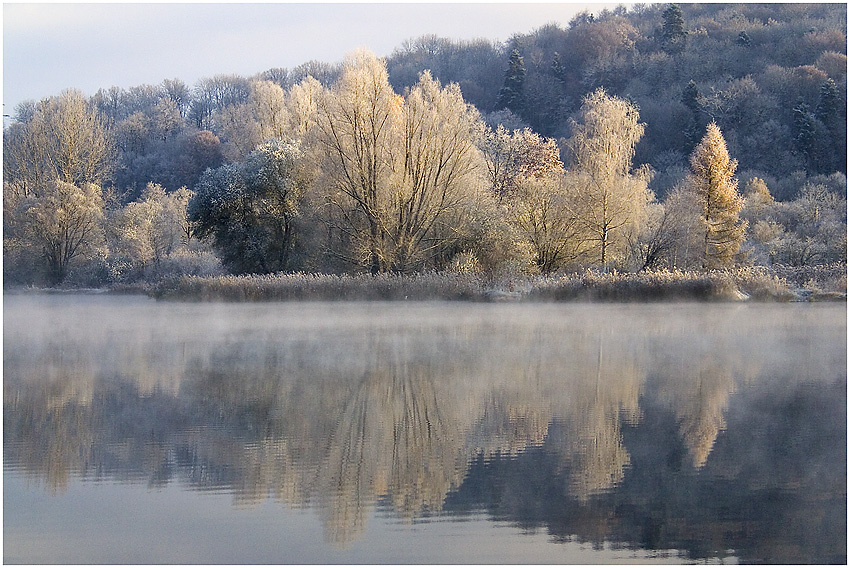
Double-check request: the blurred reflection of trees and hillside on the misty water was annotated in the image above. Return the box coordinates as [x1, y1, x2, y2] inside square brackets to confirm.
[4, 300, 846, 561]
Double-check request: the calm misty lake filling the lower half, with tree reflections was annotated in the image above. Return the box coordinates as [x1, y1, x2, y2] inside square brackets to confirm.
[3, 294, 847, 564]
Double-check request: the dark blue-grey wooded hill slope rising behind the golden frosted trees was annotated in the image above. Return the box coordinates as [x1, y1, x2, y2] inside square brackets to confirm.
[387, 4, 847, 199]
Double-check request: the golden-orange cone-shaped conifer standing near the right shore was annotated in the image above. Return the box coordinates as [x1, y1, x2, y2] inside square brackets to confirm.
[687, 122, 747, 268]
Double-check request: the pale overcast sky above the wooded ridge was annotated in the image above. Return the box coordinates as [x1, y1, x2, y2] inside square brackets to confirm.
[3, 2, 616, 114]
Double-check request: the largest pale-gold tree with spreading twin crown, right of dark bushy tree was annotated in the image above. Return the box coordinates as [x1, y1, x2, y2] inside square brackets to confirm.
[315, 51, 480, 273]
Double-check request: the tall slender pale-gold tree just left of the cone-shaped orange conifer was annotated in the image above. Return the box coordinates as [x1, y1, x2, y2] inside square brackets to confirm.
[568, 88, 652, 265]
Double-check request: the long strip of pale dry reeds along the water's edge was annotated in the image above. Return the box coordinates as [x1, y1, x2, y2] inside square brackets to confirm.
[150, 266, 846, 302]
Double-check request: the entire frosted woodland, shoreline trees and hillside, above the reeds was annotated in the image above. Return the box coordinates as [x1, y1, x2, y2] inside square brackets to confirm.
[3, 4, 847, 285]
